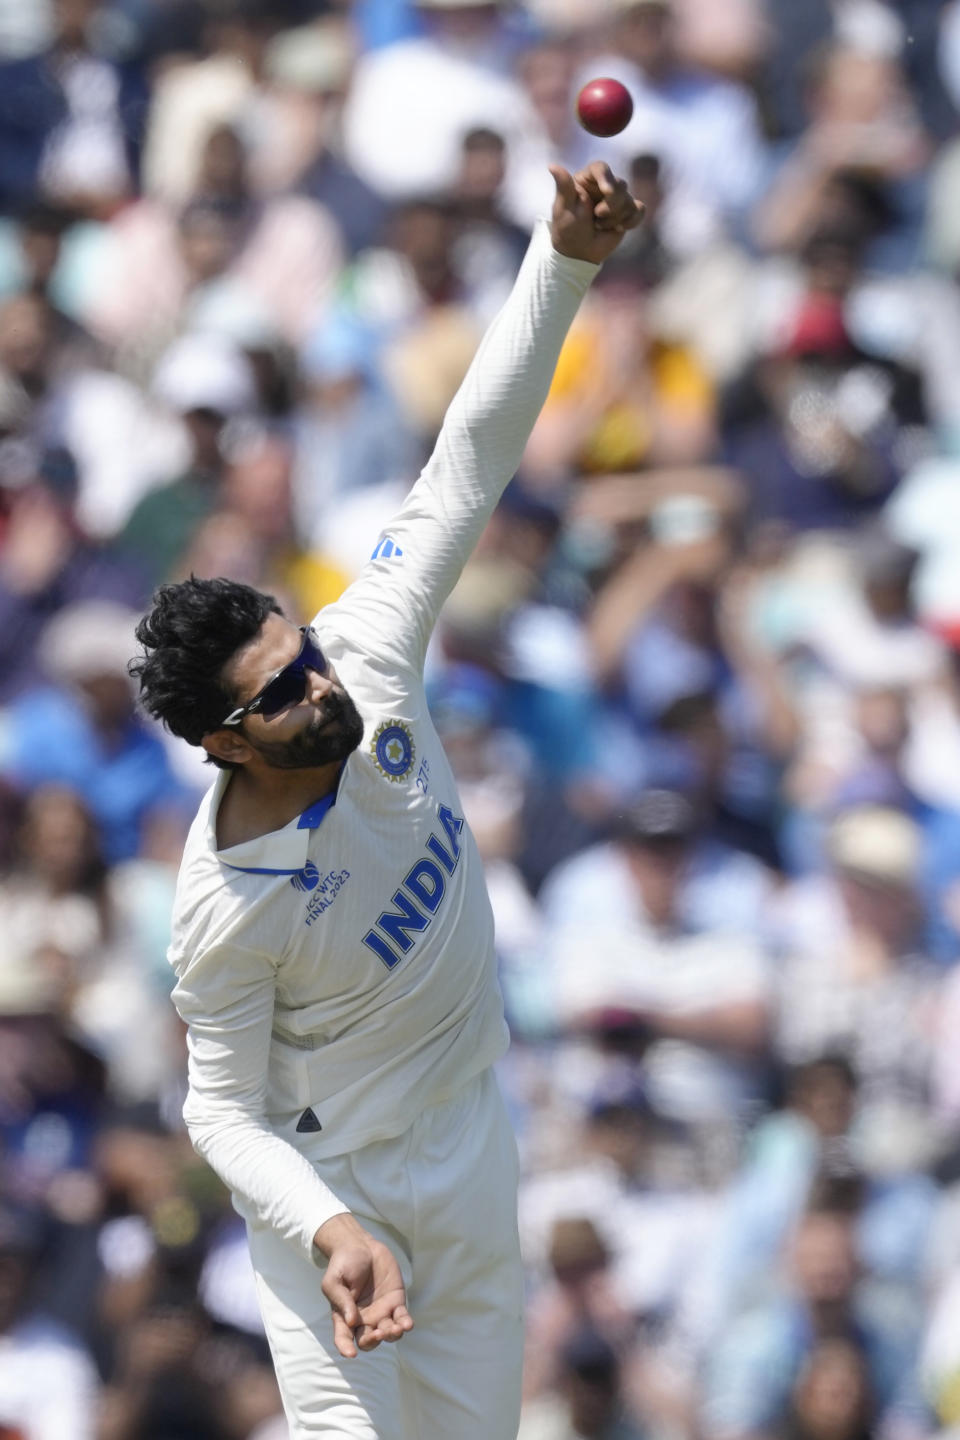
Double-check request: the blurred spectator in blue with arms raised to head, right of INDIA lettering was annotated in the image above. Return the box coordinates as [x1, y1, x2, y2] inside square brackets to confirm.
[579, 467, 796, 867]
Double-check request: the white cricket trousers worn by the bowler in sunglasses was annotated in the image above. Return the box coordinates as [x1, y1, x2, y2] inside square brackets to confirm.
[248, 1070, 522, 1440]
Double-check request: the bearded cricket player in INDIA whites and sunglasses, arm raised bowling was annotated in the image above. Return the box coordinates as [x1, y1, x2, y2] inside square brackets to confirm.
[131, 163, 640, 1440]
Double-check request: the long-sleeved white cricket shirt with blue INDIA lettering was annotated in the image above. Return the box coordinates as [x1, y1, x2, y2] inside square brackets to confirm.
[170, 222, 596, 1256]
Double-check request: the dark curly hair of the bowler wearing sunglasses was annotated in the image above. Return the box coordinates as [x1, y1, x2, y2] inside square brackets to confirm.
[128, 575, 284, 770]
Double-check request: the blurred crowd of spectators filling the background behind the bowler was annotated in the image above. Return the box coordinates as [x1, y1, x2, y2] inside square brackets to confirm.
[11, 0, 960, 1440]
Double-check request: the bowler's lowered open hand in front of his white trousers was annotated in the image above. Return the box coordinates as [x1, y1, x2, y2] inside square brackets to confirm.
[314, 1215, 413, 1359]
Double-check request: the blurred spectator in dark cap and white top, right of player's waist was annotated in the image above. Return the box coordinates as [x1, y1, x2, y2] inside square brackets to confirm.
[543, 791, 769, 1133]
